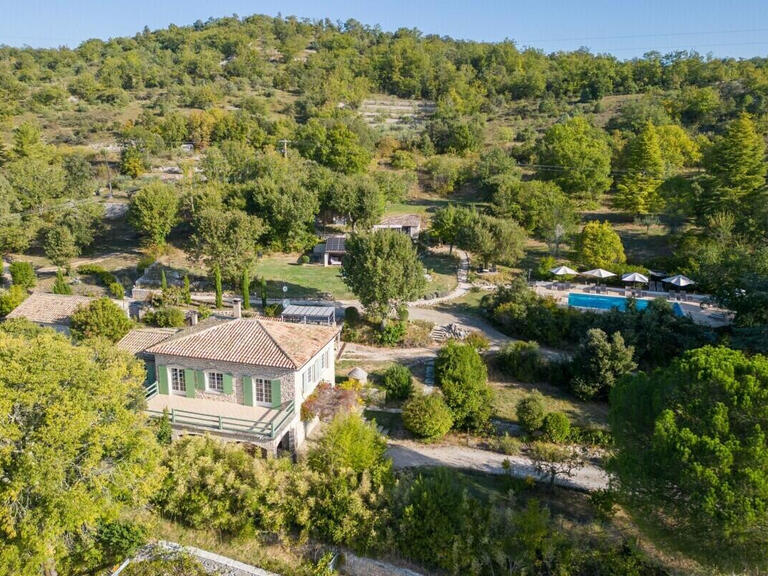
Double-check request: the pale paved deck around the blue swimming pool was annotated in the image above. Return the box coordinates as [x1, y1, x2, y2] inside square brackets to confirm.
[531, 282, 733, 328]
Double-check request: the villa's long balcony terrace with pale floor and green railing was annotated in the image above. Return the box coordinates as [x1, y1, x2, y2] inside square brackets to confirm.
[145, 382, 295, 441]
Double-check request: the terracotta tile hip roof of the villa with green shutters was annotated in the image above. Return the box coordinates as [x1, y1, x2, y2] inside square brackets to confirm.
[147, 318, 340, 370]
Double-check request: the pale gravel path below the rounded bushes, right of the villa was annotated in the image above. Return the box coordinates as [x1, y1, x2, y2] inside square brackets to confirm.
[387, 440, 608, 492]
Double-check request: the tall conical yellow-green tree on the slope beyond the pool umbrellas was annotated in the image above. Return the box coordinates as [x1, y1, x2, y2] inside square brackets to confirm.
[616, 122, 664, 214]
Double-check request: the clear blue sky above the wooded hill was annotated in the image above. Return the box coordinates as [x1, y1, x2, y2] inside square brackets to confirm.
[0, 0, 768, 58]
